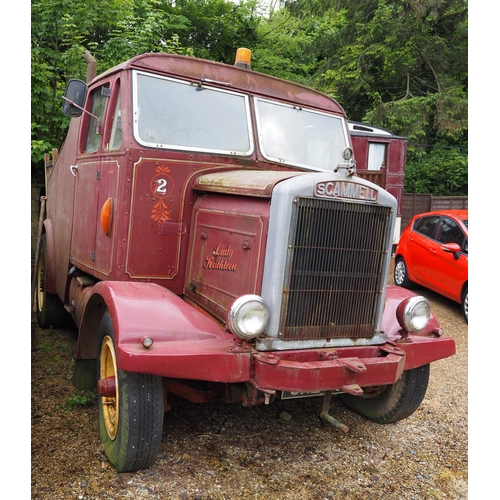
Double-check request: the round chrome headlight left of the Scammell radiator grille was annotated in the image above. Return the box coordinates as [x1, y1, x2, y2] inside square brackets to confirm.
[227, 295, 269, 340]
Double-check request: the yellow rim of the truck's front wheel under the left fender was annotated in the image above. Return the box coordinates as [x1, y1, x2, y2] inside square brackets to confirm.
[100, 335, 119, 440]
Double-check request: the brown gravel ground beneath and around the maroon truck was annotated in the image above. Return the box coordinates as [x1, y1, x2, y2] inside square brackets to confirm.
[31, 262, 468, 500]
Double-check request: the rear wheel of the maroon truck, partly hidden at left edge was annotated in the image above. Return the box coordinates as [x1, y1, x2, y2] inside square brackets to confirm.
[35, 234, 66, 328]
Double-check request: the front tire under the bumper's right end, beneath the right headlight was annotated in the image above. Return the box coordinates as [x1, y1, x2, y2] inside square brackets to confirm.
[339, 364, 430, 424]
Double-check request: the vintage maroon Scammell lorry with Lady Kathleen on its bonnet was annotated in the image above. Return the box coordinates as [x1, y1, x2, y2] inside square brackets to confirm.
[35, 49, 455, 471]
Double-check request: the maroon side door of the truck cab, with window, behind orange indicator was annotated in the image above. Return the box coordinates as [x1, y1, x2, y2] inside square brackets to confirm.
[70, 80, 119, 278]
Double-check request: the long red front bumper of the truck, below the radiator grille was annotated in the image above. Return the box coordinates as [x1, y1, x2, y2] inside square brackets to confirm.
[117, 334, 455, 394]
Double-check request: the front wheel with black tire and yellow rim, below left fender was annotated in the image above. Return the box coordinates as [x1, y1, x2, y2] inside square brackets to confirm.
[98, 312, 164, 472]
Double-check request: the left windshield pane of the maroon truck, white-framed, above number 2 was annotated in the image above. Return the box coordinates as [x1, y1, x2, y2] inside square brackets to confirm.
[133, 71, 253, 156]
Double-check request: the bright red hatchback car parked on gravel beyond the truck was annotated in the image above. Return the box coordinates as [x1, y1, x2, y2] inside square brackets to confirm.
[394, 210, 469, 323]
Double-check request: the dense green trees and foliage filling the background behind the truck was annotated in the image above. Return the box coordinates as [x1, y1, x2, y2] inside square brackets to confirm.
[31, 0, 468, 195]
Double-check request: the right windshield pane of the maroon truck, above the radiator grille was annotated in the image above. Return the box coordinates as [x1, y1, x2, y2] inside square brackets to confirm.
[255, 99, 349, 170]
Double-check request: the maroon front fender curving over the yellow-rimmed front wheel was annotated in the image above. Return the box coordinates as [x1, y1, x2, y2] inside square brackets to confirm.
[89, 281, 251, 382]
